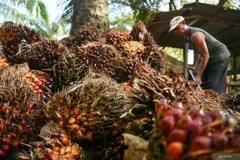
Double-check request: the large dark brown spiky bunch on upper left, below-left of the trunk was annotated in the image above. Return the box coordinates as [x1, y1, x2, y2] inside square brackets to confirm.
[18, 39, 77, 92]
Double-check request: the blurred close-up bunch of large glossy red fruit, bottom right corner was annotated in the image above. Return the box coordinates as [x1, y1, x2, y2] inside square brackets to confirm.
[149, 99, 240, 160]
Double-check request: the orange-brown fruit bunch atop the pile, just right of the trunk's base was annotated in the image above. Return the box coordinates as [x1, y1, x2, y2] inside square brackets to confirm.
[101, 28, 132, 49]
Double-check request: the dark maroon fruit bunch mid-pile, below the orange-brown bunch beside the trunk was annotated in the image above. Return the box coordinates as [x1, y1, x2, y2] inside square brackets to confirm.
[77, 42, 118, 77]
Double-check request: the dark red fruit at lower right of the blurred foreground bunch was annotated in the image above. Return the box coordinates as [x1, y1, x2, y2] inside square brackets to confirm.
[210, 133, 228, 150]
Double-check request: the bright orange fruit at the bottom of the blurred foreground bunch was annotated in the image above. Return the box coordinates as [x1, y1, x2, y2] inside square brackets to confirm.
[166, 142, 184, 160]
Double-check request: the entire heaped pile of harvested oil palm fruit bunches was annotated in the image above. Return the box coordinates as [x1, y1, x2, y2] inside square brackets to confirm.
[0, 22, 240, 160]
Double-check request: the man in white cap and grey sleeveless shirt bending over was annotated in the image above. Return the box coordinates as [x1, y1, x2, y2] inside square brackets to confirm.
[169, 16, 230, 94]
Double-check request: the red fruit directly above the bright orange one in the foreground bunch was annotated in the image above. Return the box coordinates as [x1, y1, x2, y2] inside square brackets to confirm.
[168, 129, 188, 143]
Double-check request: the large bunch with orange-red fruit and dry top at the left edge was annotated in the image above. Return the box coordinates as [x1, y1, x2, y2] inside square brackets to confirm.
[0, 63, 45, 156]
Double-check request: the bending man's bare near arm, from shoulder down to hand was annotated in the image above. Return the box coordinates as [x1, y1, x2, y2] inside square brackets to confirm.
[191, 32, 209, 83]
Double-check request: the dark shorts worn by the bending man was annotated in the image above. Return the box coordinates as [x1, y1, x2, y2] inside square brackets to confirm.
[201, 58, 229, 94]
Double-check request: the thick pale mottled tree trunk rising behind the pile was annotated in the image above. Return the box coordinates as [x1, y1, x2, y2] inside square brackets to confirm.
[70, 0, 109, 35]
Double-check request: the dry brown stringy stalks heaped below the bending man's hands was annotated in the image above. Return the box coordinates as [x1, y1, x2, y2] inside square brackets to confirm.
[133, 65, 225, 110]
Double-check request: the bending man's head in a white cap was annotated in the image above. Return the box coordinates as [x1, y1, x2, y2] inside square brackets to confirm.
[168, 16, 186, 36]
